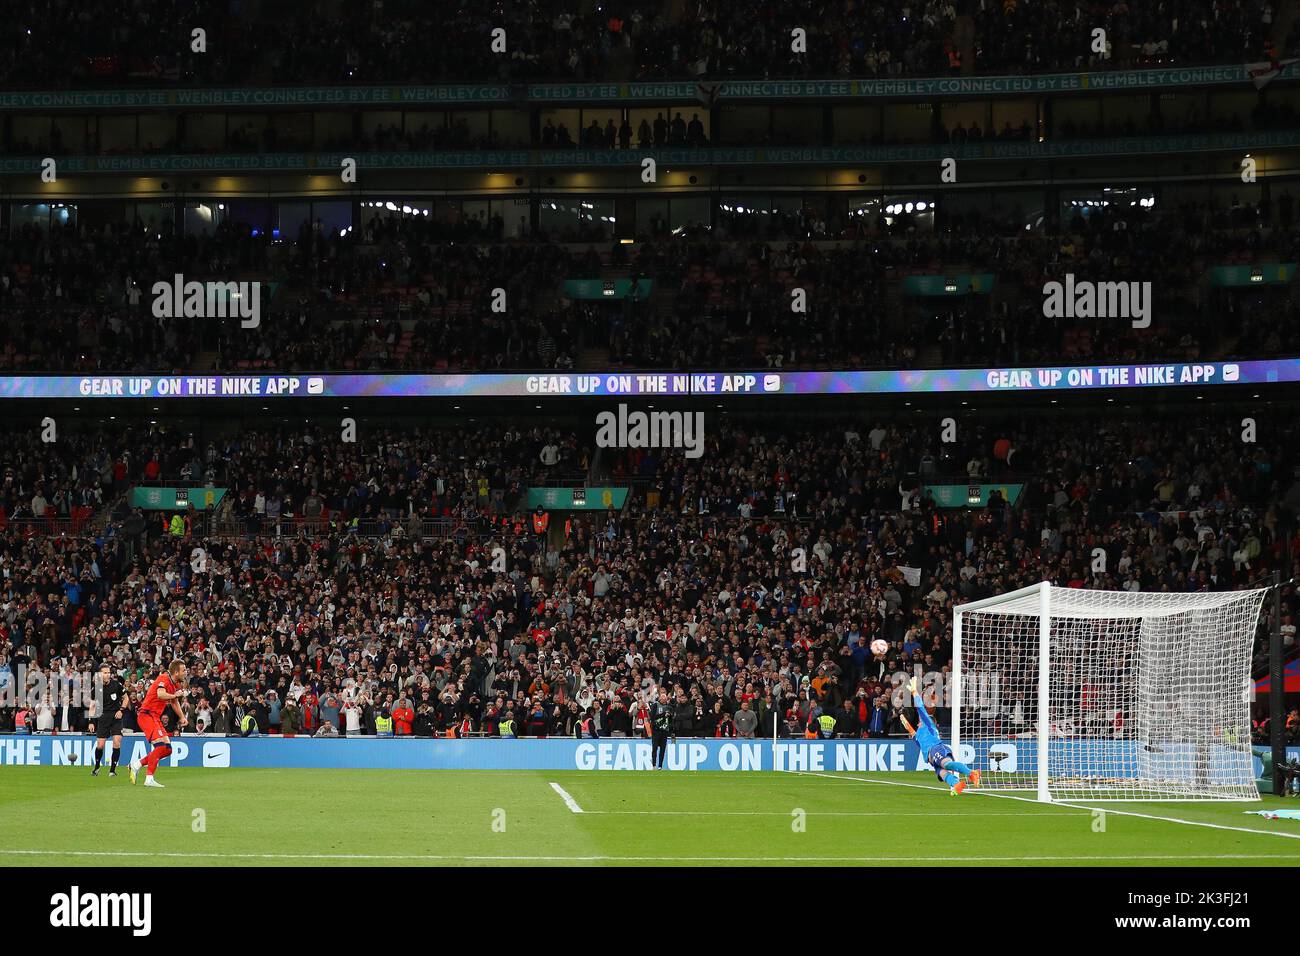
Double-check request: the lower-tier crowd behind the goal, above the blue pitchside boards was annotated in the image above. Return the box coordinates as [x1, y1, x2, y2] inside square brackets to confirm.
[0, 411, 1300, 736]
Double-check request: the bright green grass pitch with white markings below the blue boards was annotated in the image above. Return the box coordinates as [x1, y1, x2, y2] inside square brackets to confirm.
[0, 766, 1300, 866]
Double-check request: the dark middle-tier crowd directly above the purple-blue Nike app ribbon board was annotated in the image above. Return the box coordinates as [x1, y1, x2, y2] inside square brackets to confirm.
[0, 193, 1300, 371]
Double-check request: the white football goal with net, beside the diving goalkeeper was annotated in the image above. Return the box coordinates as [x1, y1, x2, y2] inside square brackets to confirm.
[950, 581, 1268, 803]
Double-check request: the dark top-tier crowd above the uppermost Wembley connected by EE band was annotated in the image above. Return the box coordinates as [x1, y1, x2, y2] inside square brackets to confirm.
[0, 0, 1294, 87]
